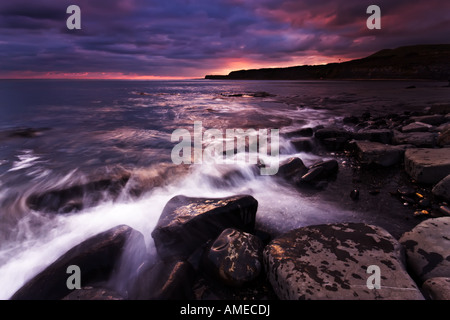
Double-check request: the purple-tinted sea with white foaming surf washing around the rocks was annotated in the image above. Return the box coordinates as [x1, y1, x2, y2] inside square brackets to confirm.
[0, 80, 450, 299]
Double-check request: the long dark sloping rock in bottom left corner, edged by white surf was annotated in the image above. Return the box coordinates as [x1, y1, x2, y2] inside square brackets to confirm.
[11, 225, 146, 300]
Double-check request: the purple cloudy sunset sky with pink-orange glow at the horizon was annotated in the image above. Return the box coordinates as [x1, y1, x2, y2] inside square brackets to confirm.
[0, 0, 450, 80]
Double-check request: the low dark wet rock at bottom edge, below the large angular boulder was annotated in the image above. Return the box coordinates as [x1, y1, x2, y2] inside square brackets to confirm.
[129, 260, 196, 300]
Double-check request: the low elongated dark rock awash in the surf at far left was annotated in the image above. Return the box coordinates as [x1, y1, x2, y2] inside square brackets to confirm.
[27, 171, 131, 213]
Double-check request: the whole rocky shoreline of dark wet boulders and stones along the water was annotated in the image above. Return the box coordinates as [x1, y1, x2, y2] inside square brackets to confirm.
[7, 100, 450, 300]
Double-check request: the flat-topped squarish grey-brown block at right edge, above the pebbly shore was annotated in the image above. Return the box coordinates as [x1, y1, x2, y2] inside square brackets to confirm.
[405, 148, 450, 184]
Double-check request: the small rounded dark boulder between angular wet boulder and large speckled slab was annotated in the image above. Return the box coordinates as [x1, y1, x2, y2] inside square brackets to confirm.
[204, 228, 263, 287]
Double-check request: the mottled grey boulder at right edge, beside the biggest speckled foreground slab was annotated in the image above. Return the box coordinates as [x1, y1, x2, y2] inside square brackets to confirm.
[400, 217, 450, 281]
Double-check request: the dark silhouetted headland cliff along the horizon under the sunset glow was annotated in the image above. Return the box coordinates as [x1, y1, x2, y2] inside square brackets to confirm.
[205, 44, 450, 80]
